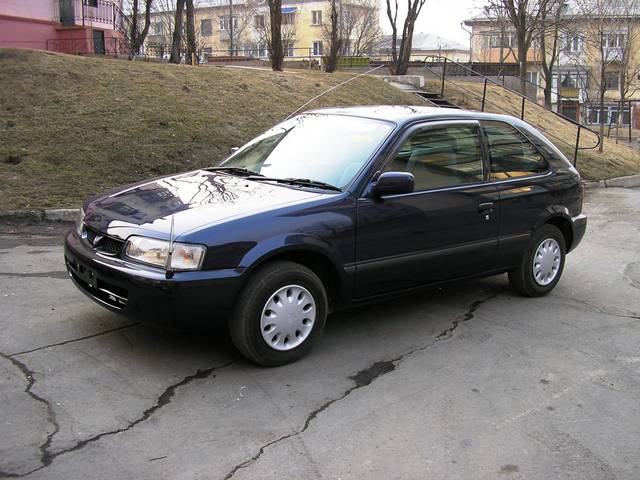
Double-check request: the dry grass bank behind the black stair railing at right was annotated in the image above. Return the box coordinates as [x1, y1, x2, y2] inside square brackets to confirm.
[429, 81, 640, 180]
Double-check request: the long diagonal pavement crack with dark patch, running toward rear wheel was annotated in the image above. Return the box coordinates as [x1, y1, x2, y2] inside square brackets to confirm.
[224, 288, 504, 480]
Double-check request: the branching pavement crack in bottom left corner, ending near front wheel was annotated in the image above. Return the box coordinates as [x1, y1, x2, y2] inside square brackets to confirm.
[0, 353, 238, 478]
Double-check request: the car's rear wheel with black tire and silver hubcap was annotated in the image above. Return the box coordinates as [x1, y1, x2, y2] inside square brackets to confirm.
[509, 224, 567, 297]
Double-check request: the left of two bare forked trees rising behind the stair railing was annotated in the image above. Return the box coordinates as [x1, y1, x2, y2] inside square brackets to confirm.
[489, 0, 555, 95]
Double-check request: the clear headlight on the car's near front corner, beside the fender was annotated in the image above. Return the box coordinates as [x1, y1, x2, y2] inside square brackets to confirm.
[124, 236, 207, 270]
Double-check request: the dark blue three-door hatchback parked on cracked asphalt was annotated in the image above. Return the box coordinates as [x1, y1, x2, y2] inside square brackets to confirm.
[65, 106, 586, 365]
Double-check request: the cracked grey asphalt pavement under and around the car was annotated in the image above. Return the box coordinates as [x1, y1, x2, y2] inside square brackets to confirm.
[0, 188, 640, 480]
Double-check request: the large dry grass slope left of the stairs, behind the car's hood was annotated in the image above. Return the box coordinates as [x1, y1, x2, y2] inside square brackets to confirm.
[0, 49, 415, 210]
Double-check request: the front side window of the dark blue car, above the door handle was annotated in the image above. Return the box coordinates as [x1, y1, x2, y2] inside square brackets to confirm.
[384, 125, 483, 191]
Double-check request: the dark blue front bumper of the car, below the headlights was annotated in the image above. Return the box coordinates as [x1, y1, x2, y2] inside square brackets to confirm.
[64, 231, 243, 328]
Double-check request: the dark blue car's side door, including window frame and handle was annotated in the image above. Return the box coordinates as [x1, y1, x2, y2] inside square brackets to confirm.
[355, 120, 500, 298]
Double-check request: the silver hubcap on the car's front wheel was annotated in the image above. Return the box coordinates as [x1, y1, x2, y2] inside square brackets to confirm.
[260, 285, 316, 351]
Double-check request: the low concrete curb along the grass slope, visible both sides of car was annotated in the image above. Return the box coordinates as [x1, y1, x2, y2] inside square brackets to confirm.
[0, 175, 640, 223]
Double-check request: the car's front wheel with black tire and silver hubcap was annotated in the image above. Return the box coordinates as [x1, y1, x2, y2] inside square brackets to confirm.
[229, 261, 328, 367]
